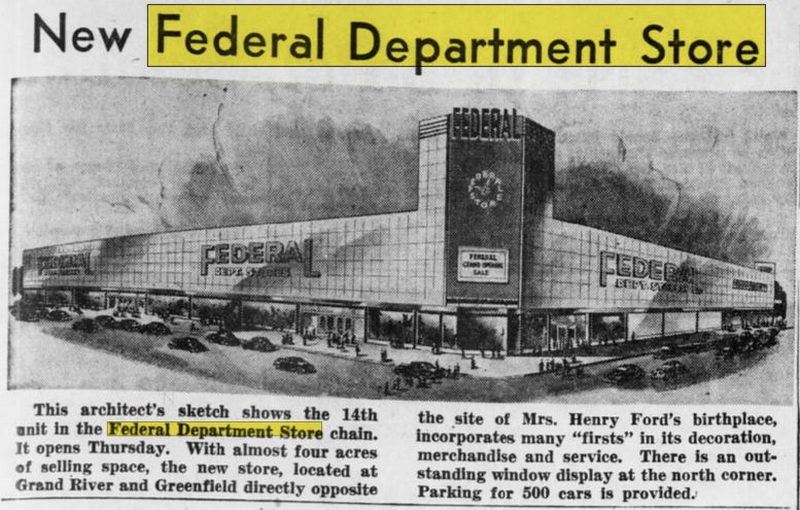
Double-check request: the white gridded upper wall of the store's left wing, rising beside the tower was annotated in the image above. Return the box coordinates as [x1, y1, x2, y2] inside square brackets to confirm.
[23, 119, 447, 306]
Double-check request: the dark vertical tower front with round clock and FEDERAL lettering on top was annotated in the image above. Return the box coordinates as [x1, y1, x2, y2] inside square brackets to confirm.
[446, 108, 525, 303]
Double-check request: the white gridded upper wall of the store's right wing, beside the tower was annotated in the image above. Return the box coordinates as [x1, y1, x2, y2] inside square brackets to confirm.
[524, 217, 774, 310]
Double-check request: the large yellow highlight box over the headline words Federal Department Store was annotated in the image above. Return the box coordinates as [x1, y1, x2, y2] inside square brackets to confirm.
[147, 4, 766, 74]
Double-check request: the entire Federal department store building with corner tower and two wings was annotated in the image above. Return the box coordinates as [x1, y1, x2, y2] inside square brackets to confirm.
[22, 108, 774, 353]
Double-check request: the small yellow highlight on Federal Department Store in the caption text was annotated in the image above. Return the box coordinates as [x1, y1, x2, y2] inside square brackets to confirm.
[106, 421, 322, 439]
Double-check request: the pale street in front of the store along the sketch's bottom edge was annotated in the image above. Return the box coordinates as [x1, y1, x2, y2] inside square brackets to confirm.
[9, 318, 795, 405]
